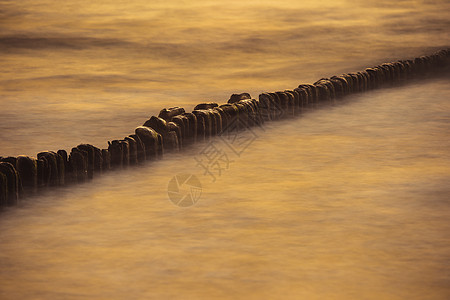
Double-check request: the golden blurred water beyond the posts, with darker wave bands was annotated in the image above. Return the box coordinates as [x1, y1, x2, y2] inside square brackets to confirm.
[0, 0, 450, 156]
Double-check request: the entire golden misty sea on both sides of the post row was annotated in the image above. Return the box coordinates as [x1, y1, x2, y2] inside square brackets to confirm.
[0, 0, 450, 299]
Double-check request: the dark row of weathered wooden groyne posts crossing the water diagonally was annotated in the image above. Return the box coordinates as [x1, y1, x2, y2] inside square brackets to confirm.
[0, 49, 450, 208]
